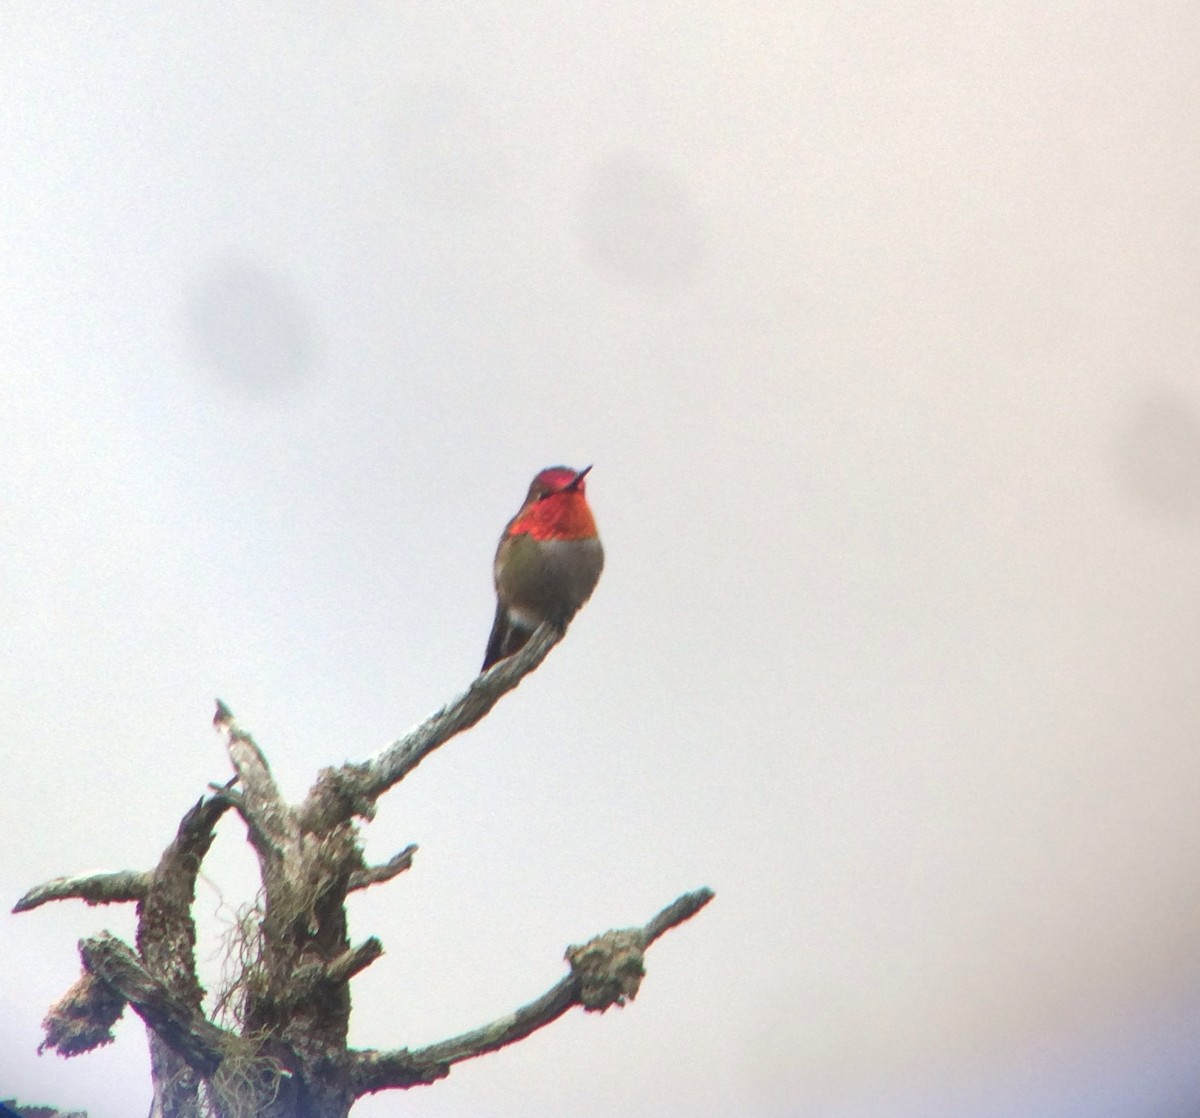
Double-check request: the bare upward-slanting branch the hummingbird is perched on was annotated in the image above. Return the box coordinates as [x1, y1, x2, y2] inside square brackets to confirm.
[300, 624, 564, 833]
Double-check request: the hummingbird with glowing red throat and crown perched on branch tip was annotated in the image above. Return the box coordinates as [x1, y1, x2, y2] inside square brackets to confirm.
[480, 465, 604, 672]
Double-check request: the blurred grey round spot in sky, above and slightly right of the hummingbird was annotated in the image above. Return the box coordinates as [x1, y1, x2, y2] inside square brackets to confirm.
[582, 155, 704, 290]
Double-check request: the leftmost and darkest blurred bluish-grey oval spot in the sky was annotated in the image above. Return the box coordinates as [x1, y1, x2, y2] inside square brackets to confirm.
[187, 259, 313, 392]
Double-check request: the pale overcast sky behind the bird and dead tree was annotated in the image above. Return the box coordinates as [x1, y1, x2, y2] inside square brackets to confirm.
[0, 8, 1200, 1118]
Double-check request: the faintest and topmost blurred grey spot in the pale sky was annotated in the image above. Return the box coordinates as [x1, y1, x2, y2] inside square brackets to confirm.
[385, 84, 504, 212]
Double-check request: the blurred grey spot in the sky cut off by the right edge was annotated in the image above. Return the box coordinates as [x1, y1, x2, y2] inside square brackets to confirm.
[1117, 389, 1200, 524]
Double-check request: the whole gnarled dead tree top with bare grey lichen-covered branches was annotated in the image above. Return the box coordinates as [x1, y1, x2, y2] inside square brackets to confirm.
[14, 625, 713, 1118]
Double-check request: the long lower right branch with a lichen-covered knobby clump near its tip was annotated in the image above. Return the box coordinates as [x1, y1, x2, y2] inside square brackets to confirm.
[350, 889, 713, 1098]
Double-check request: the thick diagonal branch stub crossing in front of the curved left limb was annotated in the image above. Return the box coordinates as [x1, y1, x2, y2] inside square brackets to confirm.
[79, 932, 233, 1076]
